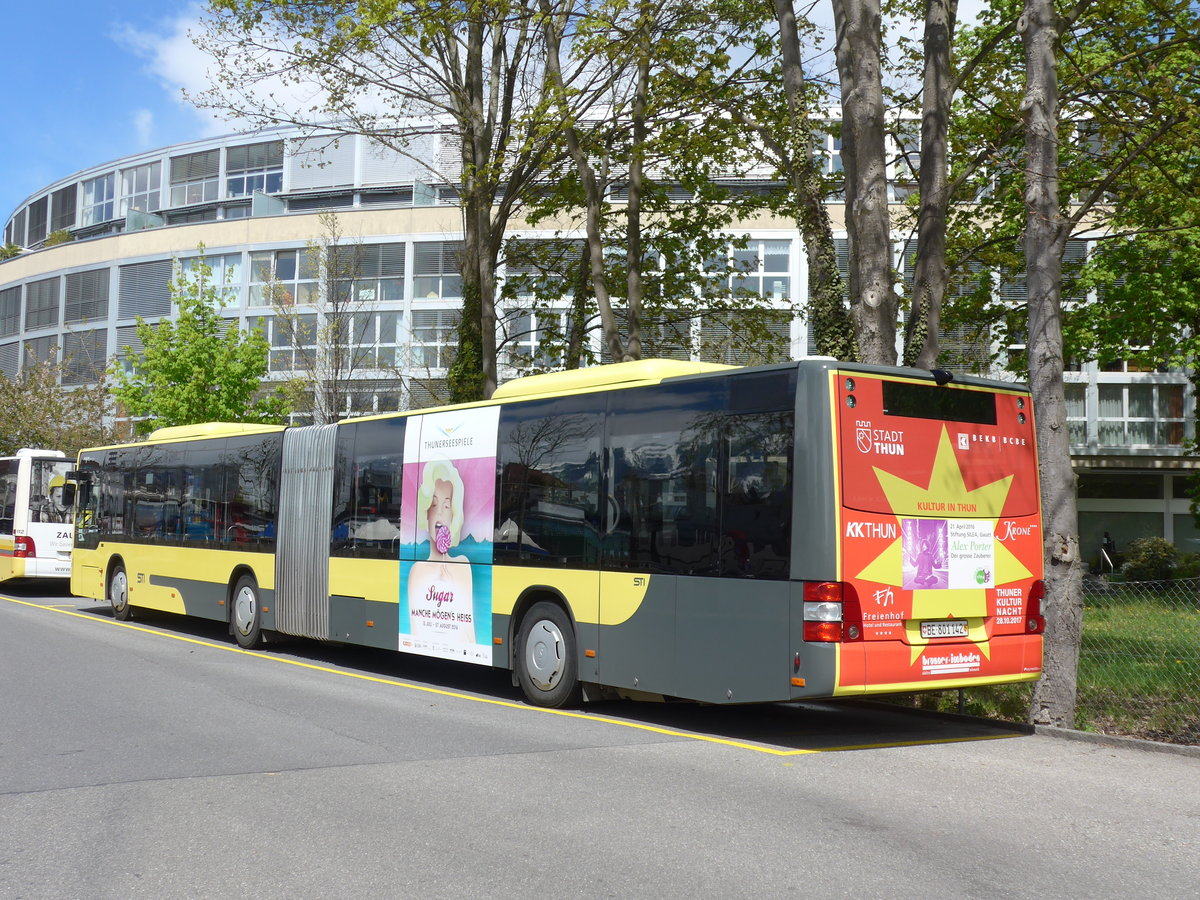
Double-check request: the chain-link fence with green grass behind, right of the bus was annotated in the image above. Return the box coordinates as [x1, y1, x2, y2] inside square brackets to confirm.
[1075, 578, 1200, 744]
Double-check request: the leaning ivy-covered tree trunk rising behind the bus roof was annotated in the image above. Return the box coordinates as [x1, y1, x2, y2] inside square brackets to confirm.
[775, 0, 858, 360]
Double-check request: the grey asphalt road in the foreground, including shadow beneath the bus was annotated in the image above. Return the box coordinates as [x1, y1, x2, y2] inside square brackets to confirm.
[0, 589, 1200, 900]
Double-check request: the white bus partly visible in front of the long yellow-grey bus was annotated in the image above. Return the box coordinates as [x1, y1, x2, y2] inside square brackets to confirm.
[0, 449, 74, 582]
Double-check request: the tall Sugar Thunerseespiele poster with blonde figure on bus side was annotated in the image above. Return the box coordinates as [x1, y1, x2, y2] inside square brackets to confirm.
[398, 407, 499, 665]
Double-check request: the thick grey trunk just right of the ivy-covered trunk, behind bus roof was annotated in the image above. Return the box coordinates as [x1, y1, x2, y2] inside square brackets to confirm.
[833, 0, 899, 365]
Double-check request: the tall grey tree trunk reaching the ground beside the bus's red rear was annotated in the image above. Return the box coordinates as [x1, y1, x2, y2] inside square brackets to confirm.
[1018, 0, 1084, 727]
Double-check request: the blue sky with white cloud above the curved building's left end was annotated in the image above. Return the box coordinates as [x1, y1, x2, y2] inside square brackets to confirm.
[0, 0, 226, 222]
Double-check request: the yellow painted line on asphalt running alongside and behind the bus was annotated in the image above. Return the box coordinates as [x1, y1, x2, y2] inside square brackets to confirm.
[0, 602, 1019, 756]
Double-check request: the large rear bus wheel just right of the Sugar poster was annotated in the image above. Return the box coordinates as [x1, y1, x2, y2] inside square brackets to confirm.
[516, 601, 581, 709]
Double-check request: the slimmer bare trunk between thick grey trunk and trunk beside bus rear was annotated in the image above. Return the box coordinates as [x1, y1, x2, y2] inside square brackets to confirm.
[904, 0, 958, 368]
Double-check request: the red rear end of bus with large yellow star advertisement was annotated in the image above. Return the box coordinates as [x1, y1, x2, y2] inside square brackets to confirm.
[834, 371, 1042, 691]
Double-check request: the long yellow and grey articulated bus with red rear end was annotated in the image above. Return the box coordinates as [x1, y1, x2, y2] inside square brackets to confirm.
[71, 359, 1044, 707]
